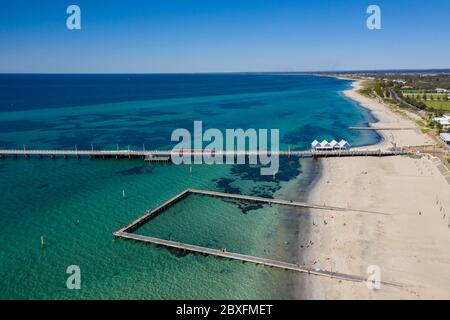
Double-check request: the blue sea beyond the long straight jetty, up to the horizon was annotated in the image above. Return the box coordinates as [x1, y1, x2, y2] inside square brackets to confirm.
[0, 74, 375, 149]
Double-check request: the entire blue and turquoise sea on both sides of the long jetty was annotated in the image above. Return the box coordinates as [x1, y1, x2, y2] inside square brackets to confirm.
[0, 75, 378, 299]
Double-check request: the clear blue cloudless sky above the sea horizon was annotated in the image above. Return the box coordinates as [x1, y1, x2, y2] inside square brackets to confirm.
[0, 0, 450, 72]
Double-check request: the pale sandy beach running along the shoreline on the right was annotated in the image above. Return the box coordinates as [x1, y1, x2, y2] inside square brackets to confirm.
[299, 82, 450, 299]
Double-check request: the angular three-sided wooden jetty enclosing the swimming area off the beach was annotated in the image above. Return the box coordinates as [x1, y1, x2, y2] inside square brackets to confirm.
[113, 189, 400, 286]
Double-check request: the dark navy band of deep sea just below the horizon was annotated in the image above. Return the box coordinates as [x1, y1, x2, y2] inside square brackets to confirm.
[0, 74, 334, 111]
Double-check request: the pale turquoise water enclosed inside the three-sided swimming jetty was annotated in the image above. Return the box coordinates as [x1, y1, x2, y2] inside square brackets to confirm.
[135, 195, 300, 262]
